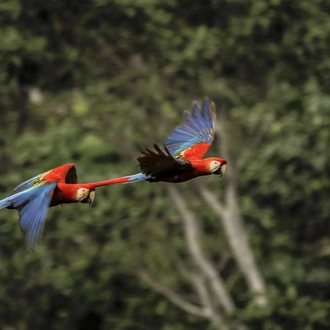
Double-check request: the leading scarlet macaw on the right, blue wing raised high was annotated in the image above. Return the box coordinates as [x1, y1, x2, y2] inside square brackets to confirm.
[111, 98, 227, 183]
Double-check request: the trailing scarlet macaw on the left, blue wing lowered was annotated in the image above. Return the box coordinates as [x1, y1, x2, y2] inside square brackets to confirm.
[0, 164, 135, 249]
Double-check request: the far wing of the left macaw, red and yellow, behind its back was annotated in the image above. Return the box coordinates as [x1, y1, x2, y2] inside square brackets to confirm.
[13, 164, 78, 194]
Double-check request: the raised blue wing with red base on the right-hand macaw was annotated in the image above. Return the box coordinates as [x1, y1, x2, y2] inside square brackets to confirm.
[164, 98, 216, 159]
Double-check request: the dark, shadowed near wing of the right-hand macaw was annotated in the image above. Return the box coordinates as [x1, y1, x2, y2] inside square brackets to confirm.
[138, 144, 193, 178]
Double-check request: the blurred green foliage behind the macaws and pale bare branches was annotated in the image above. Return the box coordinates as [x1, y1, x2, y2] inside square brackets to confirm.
[0, 0, 330, 330]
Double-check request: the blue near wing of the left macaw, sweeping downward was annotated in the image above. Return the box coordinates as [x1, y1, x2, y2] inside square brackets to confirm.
[0, 182, 57, 249]
